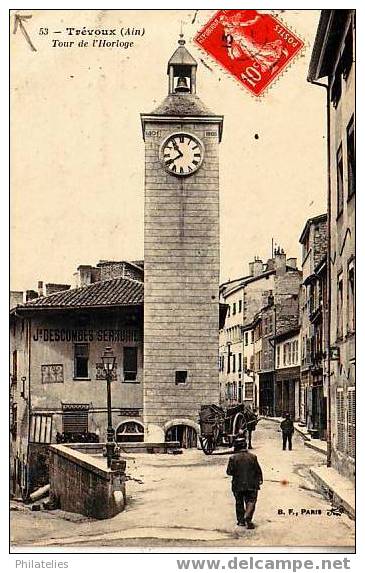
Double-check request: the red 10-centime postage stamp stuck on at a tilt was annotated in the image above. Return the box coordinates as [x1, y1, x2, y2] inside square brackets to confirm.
[194, 10, 304, 96]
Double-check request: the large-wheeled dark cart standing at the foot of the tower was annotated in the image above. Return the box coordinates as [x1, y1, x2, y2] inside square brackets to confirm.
[199, 404, 257, 455]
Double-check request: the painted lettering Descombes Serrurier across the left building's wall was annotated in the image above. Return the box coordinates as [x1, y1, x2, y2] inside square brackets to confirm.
[33, 328, 139, 342]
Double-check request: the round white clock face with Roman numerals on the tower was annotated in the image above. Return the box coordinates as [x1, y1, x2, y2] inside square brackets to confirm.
[161, 133, 204, 177]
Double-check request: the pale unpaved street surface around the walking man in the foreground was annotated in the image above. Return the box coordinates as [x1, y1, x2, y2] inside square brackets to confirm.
[11, 420, 355, 548]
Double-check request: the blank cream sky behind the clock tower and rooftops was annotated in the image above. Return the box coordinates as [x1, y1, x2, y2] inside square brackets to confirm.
[10, 10, 326, 290]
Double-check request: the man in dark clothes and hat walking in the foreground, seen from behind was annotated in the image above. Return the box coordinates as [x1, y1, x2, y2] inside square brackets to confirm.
[227, 438, 263, 529]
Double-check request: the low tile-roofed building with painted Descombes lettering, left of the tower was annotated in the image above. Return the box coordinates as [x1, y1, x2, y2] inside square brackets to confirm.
[10, 278, 144, 498]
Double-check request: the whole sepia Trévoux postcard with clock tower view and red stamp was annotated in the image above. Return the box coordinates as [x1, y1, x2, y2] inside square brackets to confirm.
[9, 9, 356, 552]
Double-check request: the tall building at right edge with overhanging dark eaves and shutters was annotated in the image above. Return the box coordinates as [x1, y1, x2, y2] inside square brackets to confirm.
[308, 10, 356, 479]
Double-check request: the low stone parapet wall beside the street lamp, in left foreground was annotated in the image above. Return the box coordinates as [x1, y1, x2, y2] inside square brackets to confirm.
[49, 446, 126, 519]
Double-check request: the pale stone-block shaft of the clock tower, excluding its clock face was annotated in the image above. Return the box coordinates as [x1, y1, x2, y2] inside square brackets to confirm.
[144, 119, 219, 441]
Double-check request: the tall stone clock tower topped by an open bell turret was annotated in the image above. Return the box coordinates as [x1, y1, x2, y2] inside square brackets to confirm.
[141, 35, 223, 445]
